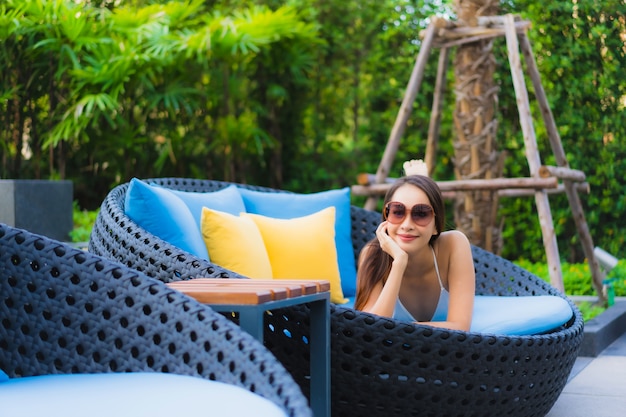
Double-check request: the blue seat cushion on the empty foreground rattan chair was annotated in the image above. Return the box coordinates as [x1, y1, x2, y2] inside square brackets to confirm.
[0, 372, 286, 417]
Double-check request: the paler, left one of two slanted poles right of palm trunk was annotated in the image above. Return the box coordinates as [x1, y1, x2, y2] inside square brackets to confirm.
[505, 14, 565, 292]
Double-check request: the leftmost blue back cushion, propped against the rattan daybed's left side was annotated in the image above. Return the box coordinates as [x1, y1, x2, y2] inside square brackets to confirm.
[124, 178, 208, 259]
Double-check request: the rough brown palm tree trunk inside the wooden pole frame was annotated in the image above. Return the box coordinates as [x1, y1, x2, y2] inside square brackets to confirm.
[454, 0, 503, 253]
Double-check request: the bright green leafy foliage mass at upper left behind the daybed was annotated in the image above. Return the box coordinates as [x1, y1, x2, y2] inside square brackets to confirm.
[0, 0, 317, 180]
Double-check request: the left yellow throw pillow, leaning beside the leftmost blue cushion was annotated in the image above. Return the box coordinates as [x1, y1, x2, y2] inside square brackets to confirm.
[200, 207, 272, 279]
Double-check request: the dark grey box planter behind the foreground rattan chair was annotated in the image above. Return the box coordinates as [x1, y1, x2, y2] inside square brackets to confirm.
[0, 180, 74, 241]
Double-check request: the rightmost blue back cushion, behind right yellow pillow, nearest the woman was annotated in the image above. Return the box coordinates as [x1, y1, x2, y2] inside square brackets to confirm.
[239, 187, 356, 297]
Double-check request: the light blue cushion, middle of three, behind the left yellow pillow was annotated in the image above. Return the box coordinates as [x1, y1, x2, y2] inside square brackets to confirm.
[169, 185, 246, 229]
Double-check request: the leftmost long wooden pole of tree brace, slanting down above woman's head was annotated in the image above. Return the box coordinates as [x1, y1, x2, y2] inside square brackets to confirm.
[365, 17, 439, 210]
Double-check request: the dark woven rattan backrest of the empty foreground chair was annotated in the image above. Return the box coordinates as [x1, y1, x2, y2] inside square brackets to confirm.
[0, 224, 311, 417]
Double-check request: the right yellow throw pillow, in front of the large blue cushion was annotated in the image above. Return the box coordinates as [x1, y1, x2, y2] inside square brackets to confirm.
[241, 207, 347, 304]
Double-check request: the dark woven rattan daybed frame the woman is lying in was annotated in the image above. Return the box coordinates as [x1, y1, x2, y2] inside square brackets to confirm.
[89, 178, 583, 417]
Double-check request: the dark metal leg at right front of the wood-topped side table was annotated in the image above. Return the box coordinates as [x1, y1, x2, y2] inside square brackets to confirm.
[309, 298, 330, 417]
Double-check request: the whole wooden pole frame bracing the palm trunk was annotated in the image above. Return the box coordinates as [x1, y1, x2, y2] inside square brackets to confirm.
[352, 14, 605, 301]
